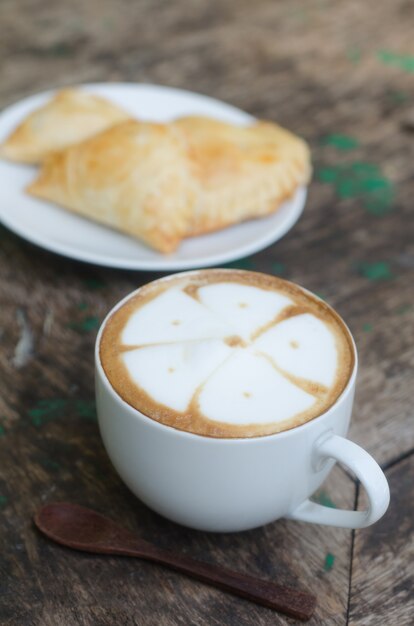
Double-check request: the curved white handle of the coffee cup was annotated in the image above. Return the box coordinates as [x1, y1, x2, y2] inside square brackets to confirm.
[286, 434, 390, 528]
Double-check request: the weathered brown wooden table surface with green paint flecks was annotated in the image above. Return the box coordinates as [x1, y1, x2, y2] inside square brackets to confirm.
[0, 0, 414, 626]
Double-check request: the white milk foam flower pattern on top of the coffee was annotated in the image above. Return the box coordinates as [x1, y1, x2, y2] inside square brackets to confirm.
[122, 282, 337, 425]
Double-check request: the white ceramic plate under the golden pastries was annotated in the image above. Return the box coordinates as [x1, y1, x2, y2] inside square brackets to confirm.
[0, 83, 306, 271]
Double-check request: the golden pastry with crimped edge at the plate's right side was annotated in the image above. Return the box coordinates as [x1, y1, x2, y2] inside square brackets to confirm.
[174, 117, 310, 235]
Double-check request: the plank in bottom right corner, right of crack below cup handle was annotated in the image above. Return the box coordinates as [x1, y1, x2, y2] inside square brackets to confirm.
[349, 455, 414, 626]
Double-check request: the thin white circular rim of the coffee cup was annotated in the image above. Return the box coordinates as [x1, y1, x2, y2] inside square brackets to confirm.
[94, 268, 358, 445]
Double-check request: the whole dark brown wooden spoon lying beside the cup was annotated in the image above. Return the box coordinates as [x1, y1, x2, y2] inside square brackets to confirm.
[34, 502, 316, 620]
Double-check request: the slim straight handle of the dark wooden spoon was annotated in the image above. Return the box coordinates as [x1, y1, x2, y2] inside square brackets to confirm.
[115, 546, 316, 620]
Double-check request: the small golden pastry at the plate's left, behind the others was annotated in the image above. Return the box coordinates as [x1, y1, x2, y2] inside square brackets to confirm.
[0, 89, 131, 163]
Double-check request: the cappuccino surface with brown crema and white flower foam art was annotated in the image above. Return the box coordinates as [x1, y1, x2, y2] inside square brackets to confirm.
[99, 269, 354, 438]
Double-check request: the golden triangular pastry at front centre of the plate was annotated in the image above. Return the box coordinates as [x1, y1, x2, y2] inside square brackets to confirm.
[28, 120, 195, 252]
